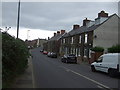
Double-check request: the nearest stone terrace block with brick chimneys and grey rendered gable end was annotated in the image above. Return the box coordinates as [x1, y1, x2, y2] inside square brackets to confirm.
[60, 11, 120, 61]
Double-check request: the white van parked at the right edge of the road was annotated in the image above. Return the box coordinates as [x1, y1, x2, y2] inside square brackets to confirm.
[91, 53, 120, 76]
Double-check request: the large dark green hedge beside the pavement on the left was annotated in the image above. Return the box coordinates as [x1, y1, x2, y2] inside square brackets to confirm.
[2, 32, 30, 88]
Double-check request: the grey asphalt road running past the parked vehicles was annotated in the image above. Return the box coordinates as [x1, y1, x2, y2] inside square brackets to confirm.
[31, 48, 120, 90]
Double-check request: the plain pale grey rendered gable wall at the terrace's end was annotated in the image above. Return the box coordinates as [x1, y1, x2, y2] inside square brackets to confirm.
[93, 15, 120, 49]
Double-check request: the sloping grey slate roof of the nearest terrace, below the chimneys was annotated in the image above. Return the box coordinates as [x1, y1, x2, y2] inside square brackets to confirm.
[63, 14, 120, 37]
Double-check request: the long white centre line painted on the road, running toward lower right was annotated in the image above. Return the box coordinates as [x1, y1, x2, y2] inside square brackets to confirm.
[59, 66, 113, 90]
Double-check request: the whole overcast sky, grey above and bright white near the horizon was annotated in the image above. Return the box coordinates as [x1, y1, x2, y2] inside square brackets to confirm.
[0, 0, 118, 40]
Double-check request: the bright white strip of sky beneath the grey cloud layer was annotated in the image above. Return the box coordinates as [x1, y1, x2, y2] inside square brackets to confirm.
[8, 27, 56, 41]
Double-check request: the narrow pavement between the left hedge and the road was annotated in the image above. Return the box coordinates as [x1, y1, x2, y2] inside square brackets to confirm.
[12, 57, 33, 88]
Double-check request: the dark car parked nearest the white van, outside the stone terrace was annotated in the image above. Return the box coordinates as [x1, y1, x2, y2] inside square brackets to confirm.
[61, 54, 77, 63]
